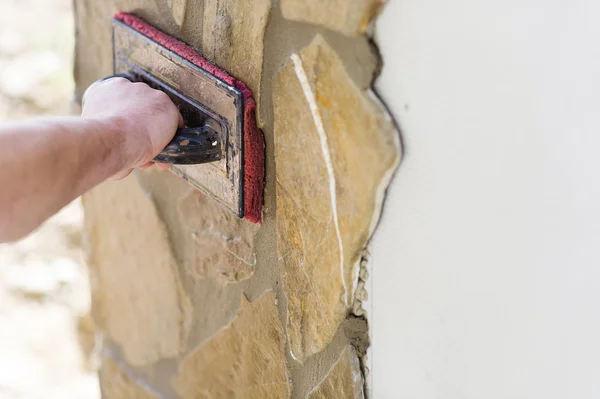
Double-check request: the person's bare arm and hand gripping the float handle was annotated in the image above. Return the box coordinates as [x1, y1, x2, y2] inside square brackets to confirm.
[0, 78, 183, 242]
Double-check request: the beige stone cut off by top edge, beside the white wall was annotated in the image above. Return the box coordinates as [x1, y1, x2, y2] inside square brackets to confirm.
[281, 0, 385, 36]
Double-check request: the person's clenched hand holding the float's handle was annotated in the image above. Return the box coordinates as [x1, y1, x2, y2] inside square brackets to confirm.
[81, 78, 184, 179]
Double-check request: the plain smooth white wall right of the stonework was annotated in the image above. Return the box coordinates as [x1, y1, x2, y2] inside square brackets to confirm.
[370, 0, 600, 399]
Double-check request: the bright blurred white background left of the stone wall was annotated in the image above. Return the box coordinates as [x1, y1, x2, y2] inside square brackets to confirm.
[0, 0, 100, 399]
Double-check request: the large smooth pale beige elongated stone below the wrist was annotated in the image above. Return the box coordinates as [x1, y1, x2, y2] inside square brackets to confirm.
[84, 176, 191, 366]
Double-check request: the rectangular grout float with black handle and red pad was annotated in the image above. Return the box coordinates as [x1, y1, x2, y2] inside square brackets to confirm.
[112, 12, 265, 223]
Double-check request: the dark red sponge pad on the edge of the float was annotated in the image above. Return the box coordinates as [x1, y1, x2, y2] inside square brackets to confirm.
[115, 12, 265, 224]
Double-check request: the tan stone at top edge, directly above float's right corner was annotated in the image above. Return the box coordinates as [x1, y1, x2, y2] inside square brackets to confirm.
[202, 0, 271, 104]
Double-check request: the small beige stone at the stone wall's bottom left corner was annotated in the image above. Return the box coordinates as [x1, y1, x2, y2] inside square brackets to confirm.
[100, 357, 159, 399]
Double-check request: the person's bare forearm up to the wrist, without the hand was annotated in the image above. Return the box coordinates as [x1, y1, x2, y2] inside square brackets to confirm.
[0, 117, 128, 242]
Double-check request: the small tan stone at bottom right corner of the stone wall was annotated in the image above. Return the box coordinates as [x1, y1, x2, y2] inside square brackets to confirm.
[308, 346, 364, 399]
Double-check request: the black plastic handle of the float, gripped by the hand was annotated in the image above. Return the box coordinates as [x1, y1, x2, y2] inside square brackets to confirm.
[103, 73, 222, 165]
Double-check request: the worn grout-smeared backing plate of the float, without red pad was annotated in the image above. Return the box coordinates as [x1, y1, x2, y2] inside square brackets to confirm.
[113, 20, 243, 217]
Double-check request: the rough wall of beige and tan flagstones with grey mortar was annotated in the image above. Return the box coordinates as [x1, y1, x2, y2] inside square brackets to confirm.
[75, 0, 400, 399]
